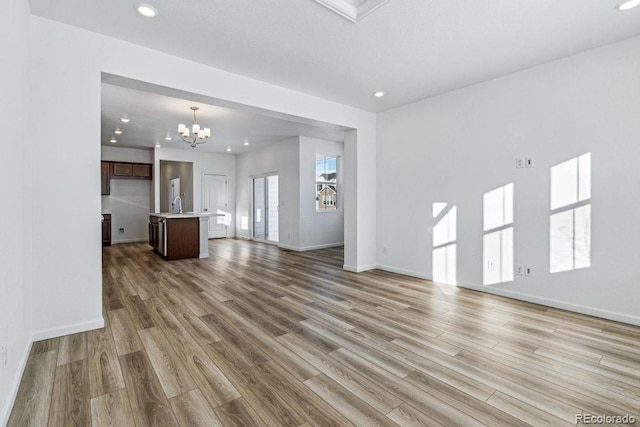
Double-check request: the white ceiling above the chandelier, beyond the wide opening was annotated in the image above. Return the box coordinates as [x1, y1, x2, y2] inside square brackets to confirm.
[101, 81, 345, 154]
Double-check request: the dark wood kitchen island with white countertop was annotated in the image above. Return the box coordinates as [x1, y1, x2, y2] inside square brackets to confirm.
[149, 212, 217, 261]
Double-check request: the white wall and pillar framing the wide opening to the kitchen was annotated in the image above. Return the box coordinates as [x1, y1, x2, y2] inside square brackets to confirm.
[29, 17, 376, 348]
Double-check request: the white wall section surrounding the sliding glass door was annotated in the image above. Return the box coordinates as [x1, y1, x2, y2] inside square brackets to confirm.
[236, 138, 300, 248]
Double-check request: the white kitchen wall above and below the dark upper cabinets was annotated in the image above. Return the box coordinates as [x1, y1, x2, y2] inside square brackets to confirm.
[100, 146, 153, 243]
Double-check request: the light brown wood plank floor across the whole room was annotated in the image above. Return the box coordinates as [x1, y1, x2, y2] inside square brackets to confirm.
[9, 239, 640, 426]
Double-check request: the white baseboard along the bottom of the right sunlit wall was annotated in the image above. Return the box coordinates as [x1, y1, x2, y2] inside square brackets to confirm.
[372, 265, 640, 326]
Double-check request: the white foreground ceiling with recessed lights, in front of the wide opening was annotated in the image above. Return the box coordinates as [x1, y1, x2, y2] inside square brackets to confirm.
[30, 0, 640, 112]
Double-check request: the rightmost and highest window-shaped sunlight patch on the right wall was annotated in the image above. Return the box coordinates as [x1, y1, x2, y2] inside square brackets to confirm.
[549, 153, 591, 273]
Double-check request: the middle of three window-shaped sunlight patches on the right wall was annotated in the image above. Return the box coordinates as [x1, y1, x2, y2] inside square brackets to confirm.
[482, 184, 513, 285]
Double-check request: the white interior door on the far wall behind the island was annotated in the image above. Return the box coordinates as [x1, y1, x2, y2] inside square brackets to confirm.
[202, 173, 231, 239]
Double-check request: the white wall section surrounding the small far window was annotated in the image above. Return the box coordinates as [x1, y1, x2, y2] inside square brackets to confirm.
[300, 137, 344, 250]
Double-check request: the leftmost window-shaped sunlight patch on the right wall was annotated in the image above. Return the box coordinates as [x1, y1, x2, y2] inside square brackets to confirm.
[431, 203, 458, 285]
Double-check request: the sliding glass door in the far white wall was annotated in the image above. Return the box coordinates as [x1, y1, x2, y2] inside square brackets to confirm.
[251, 174, 279, 242]
